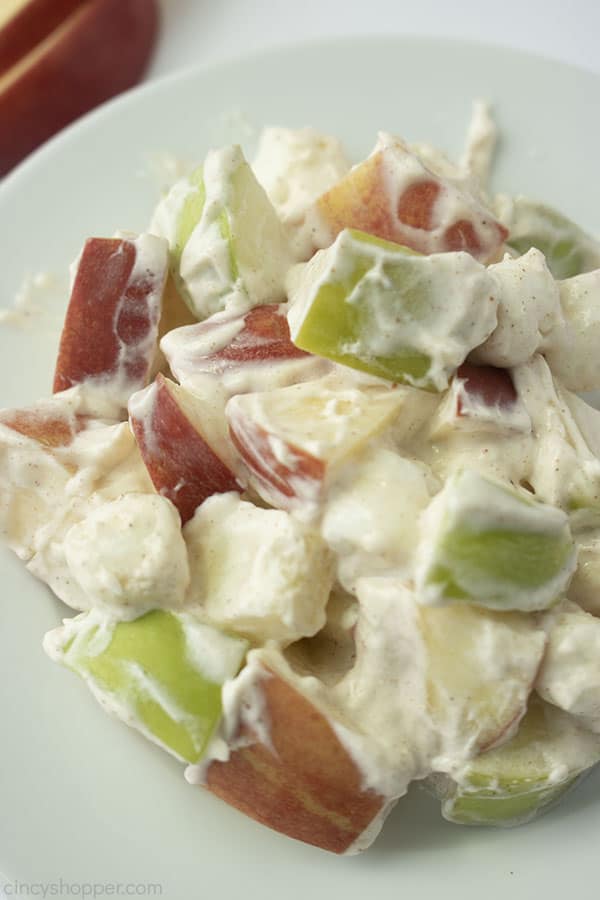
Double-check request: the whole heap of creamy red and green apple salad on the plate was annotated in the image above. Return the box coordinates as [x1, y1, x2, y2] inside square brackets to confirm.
[0, 107, 600, 853]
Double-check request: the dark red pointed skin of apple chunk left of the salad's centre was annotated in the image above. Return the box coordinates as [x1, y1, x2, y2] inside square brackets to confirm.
[130, 374, 241, 524]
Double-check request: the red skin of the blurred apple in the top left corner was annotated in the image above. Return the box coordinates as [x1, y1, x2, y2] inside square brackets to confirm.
[0, 0, 159, 175]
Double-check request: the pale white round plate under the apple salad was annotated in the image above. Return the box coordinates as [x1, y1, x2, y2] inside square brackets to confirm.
[0, 38, 600, 900]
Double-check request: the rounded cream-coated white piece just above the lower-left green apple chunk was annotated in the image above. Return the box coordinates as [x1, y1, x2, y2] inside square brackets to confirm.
[64, 493, 189, 618]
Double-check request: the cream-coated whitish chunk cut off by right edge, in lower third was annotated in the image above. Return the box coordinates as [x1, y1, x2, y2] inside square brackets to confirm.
[535, 603, 600, 733]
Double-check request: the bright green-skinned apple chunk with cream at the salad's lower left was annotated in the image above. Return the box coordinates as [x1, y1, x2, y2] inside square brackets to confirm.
[44, 610, 247, 763]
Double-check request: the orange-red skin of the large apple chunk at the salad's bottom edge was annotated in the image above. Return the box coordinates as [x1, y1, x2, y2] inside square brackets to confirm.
[206, 670, 386, 853]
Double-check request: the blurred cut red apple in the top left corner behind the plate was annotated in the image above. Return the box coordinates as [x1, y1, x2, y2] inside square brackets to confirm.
[0, 0, 159, 175]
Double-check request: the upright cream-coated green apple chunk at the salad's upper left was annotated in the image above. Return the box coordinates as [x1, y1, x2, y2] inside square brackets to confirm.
[151, 146, 291, 319]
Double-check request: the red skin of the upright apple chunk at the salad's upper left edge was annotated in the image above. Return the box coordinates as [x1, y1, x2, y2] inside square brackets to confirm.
[54, 238, 161, 404]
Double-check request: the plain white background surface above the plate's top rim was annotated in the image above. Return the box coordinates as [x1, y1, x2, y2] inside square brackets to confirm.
[149, 0, 600, 78]
